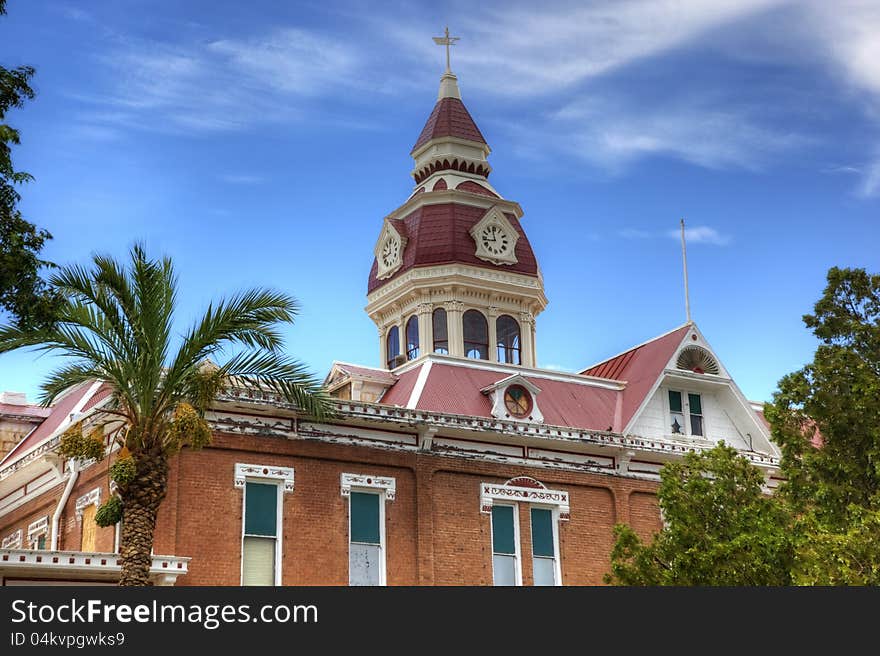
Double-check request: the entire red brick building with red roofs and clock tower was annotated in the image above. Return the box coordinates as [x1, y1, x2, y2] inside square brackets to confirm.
[0, 60, 778, 585]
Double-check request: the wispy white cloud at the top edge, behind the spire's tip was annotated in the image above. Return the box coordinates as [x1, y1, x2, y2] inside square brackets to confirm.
[383, 0, 788, 96]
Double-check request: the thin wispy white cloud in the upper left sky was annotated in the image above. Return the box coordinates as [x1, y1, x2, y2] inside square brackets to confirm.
[80, 29, 364, 132]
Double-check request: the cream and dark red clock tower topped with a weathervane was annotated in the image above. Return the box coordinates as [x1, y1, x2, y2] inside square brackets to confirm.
[366, 37, 547, 369]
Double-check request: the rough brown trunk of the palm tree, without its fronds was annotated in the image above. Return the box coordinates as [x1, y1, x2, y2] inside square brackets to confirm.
[119, 453, 168, 585]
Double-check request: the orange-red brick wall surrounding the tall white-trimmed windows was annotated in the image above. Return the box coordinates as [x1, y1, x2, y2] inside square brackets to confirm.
[0, 435, 660, 585]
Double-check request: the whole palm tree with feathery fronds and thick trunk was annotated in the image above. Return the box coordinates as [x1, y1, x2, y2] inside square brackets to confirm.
[0, 245, 331, 585]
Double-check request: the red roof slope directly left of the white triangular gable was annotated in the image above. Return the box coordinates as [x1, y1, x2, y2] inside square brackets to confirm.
[581, 324, 690, 430]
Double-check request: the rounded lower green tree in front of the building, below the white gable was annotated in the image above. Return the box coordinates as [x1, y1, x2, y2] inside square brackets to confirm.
[605, 443, 793, 586]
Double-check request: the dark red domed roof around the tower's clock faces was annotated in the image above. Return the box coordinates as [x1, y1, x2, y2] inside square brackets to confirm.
[367, 203, 538, 293]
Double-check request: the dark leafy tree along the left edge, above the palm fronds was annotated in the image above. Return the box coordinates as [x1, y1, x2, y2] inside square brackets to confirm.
[0, 0, 58, 326]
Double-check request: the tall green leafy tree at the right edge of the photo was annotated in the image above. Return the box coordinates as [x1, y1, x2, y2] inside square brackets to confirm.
[765, 267, 880, 585]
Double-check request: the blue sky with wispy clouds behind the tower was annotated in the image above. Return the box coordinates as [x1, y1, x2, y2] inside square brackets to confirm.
[0, 0, 880, 399]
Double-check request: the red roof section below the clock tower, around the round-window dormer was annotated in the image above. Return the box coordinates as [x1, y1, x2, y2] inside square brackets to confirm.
[381, 361, 621, 431]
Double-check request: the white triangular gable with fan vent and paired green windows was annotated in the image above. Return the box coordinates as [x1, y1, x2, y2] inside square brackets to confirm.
[624, 323, 779, 455]
